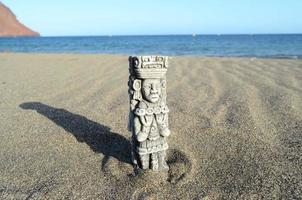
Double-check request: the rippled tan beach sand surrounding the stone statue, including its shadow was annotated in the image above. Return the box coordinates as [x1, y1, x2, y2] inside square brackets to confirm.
[0, 53, 302, 199]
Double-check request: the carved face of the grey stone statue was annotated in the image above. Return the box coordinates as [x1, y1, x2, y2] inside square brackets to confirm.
[142, 79, 161, 103]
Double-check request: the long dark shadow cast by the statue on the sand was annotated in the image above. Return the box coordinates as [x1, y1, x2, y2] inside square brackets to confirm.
[20, 102, 131, 169]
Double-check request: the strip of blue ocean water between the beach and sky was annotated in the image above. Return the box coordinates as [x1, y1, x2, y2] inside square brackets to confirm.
[0, 34, 302, 59]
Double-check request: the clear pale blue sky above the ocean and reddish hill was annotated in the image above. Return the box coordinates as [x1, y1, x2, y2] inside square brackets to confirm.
[0, 0, 302, 36]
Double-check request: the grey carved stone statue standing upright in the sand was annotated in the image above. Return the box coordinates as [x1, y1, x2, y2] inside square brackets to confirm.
[128, 56, 170, 171]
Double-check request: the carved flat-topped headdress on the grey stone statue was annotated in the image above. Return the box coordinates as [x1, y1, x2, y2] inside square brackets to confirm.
[129, 56, 168, 79]
